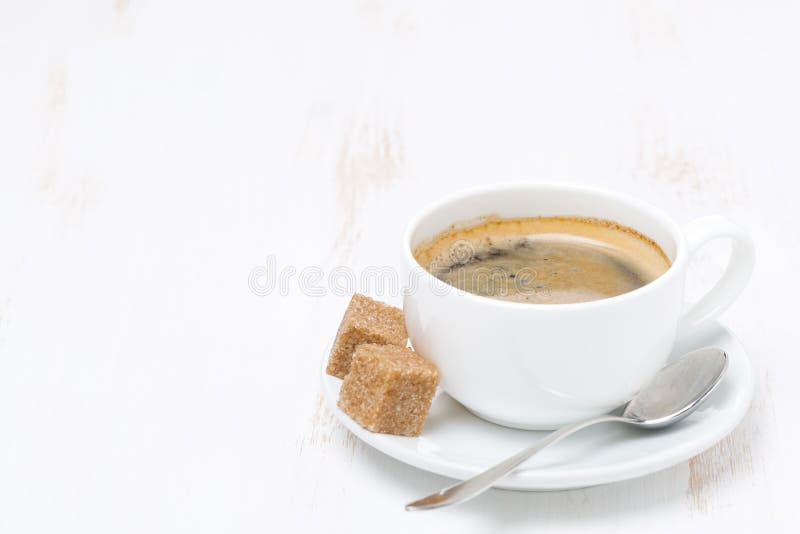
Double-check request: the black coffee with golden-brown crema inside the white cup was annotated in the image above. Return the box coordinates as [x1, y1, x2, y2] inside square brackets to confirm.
[414, 217, 670, 304]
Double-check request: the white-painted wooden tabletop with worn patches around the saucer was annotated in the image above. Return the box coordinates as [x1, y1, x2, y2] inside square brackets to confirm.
[0, 0, 800, 534]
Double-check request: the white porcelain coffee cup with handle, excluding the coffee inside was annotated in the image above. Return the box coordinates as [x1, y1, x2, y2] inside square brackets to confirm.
[403, 184, 754, 429]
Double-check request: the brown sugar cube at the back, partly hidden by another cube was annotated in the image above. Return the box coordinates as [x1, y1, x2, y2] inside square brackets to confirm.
[325, 293, 408, 378]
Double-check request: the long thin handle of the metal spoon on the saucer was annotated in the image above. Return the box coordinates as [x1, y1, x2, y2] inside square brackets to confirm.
[406, 415, 628, 511]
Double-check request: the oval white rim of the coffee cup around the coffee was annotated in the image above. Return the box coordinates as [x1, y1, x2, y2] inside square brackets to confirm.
[403, 182, 687, 311]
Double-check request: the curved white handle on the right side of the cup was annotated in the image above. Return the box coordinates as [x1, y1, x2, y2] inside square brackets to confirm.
[678, 215, 755, 333]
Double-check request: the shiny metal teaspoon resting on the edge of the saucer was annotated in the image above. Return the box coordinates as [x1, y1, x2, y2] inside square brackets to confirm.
[406, 348, 728, 511]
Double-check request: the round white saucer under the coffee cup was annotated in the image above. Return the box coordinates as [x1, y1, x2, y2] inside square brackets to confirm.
[321, 325, 753, 491]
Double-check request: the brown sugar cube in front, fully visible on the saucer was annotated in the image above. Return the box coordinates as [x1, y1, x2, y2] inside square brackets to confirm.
[339, 343, 439, 436]
